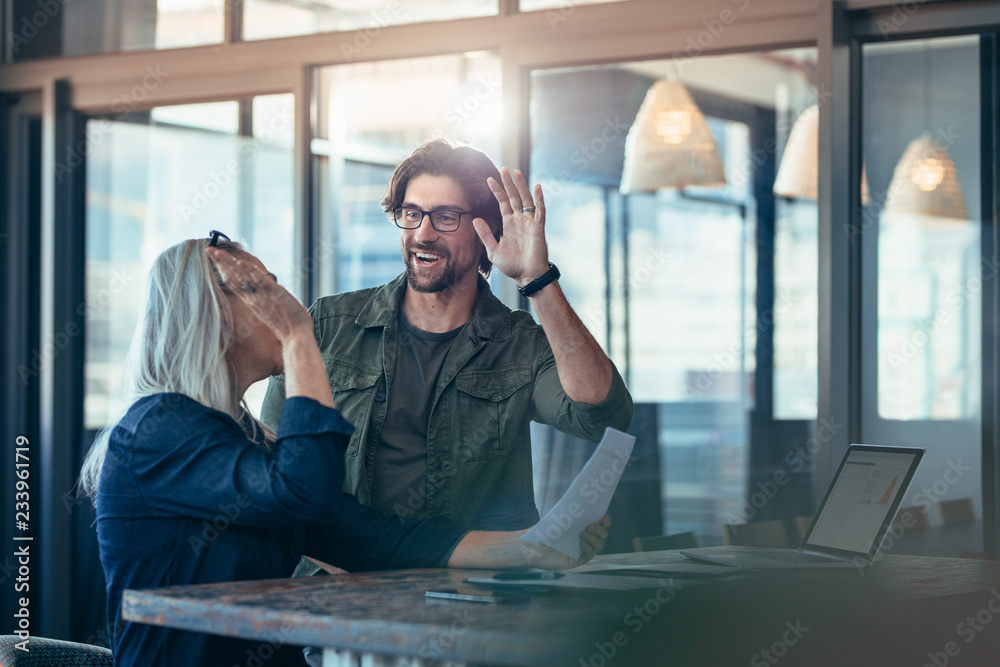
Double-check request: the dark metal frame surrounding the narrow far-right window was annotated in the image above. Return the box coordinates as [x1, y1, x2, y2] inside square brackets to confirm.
[816, 0, 1000, 558]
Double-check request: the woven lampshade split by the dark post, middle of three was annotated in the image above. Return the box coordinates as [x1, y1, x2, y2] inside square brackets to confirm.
[773, 104, 871, 204]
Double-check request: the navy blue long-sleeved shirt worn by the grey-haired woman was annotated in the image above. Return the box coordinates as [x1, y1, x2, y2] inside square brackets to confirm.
[96, 393, 465, 667]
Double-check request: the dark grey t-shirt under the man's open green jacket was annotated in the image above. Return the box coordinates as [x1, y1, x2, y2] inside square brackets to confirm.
[372, 308, 462, 519]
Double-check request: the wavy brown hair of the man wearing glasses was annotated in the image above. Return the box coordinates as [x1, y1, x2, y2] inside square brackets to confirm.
[380, 139, 503, 276]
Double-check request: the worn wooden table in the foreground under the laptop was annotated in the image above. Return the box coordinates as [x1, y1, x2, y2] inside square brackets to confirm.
[122, 552, 1000, 667]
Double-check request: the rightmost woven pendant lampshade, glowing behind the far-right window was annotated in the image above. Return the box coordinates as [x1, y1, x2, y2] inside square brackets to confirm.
[883, 133, 969, 220]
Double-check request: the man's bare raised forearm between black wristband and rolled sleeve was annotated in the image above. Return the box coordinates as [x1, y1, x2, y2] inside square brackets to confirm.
[531, 282, 614, 404]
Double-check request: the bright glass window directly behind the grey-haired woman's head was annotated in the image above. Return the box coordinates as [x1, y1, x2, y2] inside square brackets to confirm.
[84, 95, 296, 429]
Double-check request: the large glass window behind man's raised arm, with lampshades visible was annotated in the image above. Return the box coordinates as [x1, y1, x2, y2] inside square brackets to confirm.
[522, 49, 817, 543]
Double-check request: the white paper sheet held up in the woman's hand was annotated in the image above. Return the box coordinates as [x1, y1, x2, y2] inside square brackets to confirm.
[521, 426, 635, 558]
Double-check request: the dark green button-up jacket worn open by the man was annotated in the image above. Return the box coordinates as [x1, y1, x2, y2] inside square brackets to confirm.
[261, 273, 632, 530]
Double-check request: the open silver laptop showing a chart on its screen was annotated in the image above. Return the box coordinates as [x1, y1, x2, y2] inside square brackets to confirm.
[681, 445, 924, 570]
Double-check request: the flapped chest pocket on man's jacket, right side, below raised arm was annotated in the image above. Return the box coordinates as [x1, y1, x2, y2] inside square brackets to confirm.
[455, 366, 531, 462]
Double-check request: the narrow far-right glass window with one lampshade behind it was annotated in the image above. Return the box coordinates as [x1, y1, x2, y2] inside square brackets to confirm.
[860, 36, 984, 555]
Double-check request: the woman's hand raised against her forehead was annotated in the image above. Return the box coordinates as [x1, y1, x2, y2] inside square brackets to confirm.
[206, 248, 313, 345]
